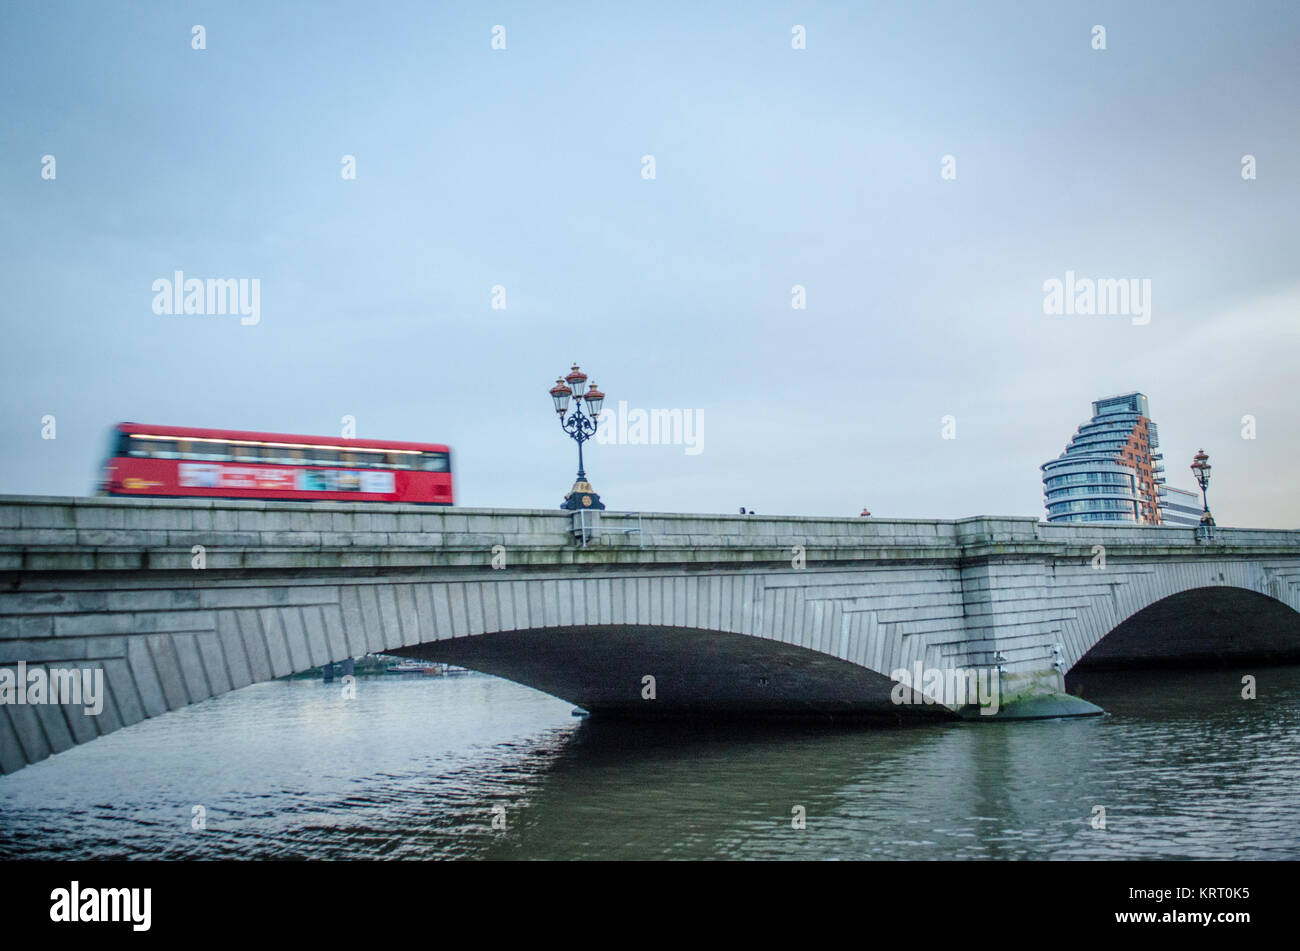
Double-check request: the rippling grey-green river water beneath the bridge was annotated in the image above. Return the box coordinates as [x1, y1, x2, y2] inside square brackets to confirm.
[0, 666, 1300, 859]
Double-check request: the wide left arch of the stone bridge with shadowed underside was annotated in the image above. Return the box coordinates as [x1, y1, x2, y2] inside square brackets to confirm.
[0, 566, 956, 773]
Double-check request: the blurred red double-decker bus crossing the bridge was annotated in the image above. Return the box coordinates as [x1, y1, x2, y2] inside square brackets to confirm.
[100, 422, 454, 505]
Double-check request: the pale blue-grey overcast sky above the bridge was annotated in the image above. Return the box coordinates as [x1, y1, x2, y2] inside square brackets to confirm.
[0, 0, 1300, 527]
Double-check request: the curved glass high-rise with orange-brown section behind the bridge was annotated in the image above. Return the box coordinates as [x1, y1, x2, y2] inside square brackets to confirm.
[1040, 392, 1201, 526]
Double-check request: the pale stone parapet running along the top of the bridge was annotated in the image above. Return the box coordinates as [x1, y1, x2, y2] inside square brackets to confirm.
[0, 496, 1300, 572]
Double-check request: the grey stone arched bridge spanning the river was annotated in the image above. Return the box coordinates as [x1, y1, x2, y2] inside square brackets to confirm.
[0, 496, 1300, 773]
